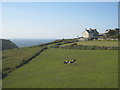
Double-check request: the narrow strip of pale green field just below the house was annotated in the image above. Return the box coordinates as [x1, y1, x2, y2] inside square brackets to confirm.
[77, 40, 118, 47]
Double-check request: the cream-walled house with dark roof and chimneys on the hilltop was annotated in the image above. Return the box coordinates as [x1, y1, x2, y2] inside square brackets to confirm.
[82, 28, 99, 40]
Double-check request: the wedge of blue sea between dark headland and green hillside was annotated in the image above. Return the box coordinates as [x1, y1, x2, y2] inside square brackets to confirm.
[10, 39, 57, 47]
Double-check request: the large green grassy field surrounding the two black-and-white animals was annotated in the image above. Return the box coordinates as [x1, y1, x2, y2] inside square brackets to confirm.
[3, 48, 118, 88]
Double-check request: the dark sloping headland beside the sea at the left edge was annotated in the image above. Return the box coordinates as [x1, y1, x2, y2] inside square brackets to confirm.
[0, 39, 19, 50]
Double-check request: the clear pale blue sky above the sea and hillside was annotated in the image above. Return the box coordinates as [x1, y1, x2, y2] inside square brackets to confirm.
[0, 2, 118, 39]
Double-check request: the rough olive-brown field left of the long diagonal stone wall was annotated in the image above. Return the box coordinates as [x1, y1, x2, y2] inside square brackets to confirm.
[2, 46, 43, 73]
